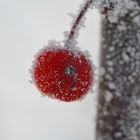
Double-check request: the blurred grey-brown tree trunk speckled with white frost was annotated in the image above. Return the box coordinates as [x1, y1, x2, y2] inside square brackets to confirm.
[96, 0, 140, 140]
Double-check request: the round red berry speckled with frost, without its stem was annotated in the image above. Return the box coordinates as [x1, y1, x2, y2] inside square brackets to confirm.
[33, 48, 93, 102]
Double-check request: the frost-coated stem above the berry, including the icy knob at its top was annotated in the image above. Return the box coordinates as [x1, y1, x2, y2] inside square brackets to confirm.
[63, 0, 116, 47]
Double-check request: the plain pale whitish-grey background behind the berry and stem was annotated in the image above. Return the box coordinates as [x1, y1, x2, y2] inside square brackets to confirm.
[0, 0, 100, 140]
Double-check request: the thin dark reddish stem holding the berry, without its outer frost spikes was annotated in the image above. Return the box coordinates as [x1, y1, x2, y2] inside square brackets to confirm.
[65, 0, 93, 48]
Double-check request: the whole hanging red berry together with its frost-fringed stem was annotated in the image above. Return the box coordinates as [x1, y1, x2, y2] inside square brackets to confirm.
[32, 0, 94, 102]
